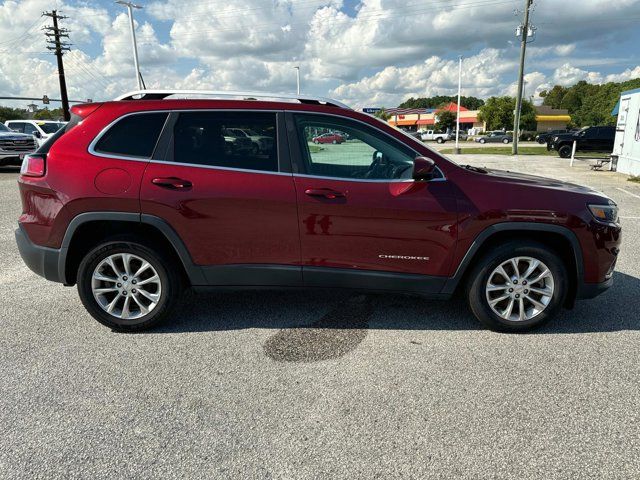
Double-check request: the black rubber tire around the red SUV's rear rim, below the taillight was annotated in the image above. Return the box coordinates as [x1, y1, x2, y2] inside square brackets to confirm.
[78, 239, 182, 332]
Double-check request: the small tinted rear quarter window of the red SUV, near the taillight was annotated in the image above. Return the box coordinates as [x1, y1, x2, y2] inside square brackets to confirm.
[94, 112, 168, 158]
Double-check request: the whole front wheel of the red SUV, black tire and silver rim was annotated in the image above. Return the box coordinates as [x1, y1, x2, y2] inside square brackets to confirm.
[468, 241, 568, 332]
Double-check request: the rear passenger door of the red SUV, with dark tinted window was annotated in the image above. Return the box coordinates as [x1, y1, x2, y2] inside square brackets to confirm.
[140, 110, 301, 285]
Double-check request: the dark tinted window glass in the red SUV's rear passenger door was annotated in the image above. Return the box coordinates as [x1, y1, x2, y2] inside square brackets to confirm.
[169, 111, 278, 172]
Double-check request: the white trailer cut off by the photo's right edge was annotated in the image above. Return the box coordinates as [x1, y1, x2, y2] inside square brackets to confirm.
[611, 88, 640, 175]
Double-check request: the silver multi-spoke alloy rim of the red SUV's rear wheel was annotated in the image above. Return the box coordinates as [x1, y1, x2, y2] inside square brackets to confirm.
[91, 253, 162, 320]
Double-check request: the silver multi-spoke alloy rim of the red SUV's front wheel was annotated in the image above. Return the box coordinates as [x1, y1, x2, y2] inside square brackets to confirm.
[485, 257, 555, 322]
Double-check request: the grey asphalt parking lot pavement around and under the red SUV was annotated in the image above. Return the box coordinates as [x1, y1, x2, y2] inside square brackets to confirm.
[0, 161, 640, 479]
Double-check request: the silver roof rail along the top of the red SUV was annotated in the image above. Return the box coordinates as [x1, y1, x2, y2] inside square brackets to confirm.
[114, 90, 351, 110]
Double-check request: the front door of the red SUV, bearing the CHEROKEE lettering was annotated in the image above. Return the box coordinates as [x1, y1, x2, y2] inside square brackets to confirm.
[287, 114, 457, 289]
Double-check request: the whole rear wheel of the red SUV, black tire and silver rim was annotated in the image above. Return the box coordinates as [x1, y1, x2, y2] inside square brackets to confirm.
[78, 241, 181, 332]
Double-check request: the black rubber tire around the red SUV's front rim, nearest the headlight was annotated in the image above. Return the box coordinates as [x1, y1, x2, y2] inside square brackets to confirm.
[467, 240, 569, 332]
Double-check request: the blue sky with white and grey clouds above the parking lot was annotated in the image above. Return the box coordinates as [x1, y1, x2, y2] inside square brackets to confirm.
[0, 0, 640, 108]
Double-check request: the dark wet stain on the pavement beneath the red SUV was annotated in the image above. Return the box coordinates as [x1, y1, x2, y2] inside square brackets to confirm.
[264, 295, 373, 362]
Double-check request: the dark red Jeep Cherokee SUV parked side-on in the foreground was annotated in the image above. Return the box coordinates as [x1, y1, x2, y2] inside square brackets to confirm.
[16, 91, 620, 331]
